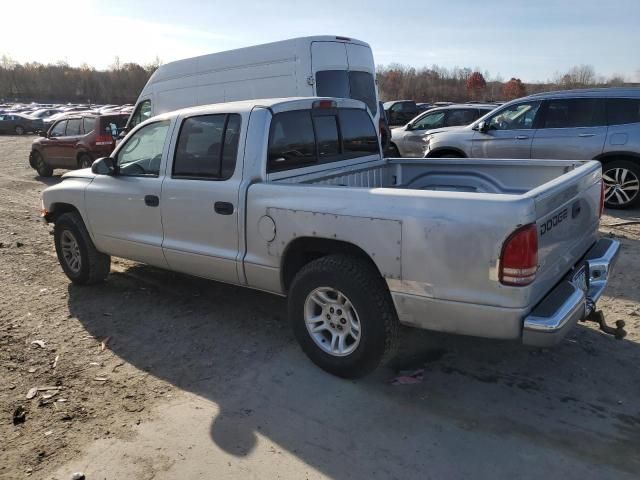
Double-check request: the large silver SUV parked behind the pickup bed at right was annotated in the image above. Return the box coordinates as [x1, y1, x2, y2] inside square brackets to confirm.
[424, 88, 640, 208]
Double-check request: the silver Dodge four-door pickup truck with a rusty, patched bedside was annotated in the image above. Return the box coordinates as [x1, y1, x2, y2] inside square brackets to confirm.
[43, 98, 619, 377]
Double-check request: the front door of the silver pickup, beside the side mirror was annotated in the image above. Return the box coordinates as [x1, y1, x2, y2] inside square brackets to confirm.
[85, 120, 171, 268]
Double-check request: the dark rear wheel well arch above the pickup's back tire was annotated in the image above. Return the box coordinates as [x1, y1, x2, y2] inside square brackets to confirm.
[280, 237, 379, 292]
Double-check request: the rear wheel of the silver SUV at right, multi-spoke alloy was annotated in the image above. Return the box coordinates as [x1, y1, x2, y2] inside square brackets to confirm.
[602, 160, 640, 209]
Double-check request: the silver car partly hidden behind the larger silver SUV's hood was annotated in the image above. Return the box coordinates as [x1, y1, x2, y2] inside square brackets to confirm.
[389, 105, 495, 158]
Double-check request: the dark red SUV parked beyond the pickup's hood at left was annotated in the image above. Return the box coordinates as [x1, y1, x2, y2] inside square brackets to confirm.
[29, 113, 129, 177]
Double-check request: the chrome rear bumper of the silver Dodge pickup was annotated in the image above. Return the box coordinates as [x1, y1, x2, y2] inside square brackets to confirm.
[522, 238, 620, 347]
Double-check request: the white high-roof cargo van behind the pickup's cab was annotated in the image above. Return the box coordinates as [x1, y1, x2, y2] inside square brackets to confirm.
[127, 36, 380, 130]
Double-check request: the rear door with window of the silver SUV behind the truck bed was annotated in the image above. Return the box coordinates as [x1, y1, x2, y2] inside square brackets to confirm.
[531, 98, 607, 160]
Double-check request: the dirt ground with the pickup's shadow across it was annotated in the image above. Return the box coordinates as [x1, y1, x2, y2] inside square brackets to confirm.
[0, 136, 640, 480]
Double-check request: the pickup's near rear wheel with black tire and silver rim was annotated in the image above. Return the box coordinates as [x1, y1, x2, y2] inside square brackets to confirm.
[289, 254, 398, 378]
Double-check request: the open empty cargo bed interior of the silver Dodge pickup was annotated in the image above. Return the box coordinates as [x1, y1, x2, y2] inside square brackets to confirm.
[270, 158, 584, 195]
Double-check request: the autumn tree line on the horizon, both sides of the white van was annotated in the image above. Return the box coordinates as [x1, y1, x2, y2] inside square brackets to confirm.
[0, 55, 636, 104]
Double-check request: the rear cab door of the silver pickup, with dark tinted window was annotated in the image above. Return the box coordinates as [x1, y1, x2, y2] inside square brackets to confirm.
[162, 114, 242, 283]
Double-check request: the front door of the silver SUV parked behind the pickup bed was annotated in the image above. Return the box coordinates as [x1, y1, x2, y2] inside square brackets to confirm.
[471, 101, 540, 158]
